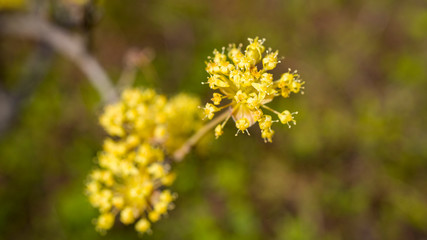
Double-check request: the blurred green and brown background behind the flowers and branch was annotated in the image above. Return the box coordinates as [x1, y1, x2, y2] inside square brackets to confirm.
[0, 0, 427, 240]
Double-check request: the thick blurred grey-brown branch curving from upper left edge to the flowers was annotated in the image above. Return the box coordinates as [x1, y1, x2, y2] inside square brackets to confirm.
[0, 15, 118, 102]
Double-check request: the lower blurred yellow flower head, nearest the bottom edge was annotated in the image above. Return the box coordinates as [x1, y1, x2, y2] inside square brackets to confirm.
[86, 139, 175, 232]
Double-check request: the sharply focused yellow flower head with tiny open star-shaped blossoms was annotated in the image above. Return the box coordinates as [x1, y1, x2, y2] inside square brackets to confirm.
[204, 37, 304, 142]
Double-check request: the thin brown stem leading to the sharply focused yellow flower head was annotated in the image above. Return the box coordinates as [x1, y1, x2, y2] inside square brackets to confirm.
[173, 109, 231, 162]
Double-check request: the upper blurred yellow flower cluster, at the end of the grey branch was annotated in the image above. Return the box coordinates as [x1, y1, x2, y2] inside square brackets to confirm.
[100, 89, 202, 153]
